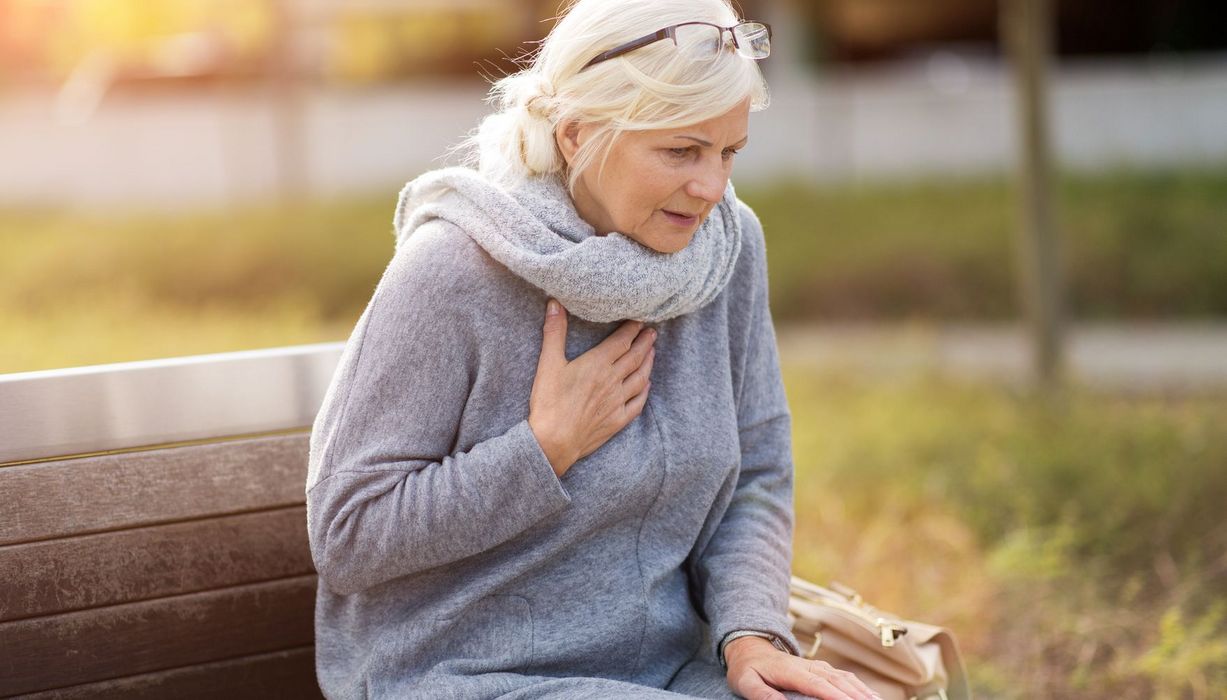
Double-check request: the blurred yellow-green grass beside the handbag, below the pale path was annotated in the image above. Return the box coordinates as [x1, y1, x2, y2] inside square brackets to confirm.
[785, 367, 1227, 699]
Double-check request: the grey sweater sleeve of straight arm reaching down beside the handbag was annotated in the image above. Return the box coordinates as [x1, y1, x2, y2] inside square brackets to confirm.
[697, 201, 799, 657]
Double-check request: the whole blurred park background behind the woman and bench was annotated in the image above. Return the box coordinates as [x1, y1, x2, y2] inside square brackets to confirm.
[0, 0, 1227, 699]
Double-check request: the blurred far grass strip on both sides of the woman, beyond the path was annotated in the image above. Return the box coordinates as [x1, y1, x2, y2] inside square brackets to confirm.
[0, 166, 1227, 372]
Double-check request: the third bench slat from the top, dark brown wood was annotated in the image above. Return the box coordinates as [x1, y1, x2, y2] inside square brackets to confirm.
[0, 575, 317, 696]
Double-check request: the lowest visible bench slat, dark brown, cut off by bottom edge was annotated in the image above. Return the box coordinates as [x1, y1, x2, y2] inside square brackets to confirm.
[23, 647, 323, 700]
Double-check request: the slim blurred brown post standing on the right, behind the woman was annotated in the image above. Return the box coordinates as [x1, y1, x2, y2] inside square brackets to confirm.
[999, 0, 1065, 388]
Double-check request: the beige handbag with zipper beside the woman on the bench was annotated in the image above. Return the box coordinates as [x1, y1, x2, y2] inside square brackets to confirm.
[788, 576, 972, 700]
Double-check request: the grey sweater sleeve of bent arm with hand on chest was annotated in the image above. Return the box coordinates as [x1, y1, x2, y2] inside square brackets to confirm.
[307, 224, 571, 594]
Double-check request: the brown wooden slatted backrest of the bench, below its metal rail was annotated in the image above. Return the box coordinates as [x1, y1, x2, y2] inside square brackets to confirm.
[0, 348, 339, 699]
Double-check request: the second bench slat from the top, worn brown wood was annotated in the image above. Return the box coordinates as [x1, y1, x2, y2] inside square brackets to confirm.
[0, 506, 314, 621]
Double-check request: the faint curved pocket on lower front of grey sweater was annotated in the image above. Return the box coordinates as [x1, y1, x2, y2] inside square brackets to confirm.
[427, 593, 533, 675]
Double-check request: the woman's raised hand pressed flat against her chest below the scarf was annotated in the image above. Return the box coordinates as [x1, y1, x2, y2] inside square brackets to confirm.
[529, 294, 656, 476]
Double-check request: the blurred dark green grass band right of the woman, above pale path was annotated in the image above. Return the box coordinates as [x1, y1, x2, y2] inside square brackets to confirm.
[739, 167, 1227, 319]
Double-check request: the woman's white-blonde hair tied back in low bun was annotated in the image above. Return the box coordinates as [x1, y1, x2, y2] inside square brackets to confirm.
[464, 0, 769, 189]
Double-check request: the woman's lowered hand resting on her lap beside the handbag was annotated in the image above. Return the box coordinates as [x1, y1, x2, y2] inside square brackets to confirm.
[724, 637, 879, 700]
